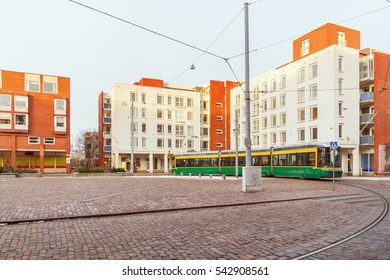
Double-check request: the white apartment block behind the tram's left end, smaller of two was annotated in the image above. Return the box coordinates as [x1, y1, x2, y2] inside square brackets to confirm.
[104, 81, 201, 173]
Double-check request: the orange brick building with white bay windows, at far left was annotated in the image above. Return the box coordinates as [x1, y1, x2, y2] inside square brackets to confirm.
[0, 70, 70, 173]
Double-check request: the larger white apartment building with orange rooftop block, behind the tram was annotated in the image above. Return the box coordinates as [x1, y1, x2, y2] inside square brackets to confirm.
[231, 25, 360, 175]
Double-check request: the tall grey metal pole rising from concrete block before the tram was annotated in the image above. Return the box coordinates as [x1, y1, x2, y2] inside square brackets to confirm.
[245, 2, 252, 166]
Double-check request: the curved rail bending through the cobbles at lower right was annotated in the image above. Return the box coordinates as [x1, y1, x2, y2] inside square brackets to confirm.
[293, 182, 389, 260]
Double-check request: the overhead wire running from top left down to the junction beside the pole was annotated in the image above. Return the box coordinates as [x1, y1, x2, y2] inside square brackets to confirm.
[69, 0, 227, 61]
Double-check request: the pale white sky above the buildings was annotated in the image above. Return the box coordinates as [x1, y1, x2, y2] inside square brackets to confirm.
[0, 0, 390, 138]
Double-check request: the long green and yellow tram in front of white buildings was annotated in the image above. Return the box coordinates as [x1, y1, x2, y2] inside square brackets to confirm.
[172, 144, 342, 179]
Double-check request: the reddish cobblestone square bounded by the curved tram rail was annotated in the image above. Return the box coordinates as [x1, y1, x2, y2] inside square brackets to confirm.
[0, 176, 390, 260]
